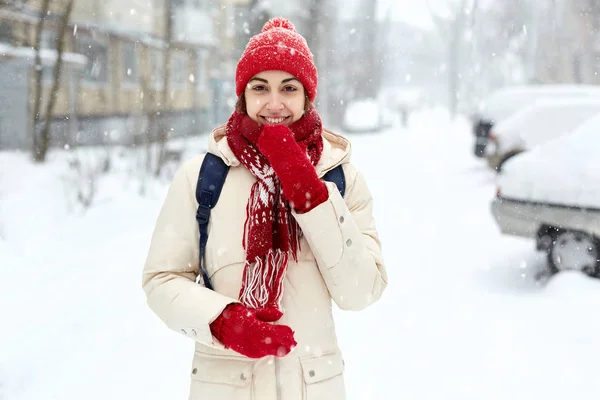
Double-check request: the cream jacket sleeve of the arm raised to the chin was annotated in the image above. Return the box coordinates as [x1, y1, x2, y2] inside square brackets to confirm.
[294, 164, 387, 311]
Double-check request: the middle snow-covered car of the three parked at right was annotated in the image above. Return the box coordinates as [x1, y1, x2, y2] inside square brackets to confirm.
[486, 97, 600, 172]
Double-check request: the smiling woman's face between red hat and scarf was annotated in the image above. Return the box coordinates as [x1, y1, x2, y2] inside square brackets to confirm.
[244, 71, 305, 125]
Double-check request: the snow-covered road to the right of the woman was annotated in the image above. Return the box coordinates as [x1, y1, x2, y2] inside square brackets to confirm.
[340, 108, 600, 400]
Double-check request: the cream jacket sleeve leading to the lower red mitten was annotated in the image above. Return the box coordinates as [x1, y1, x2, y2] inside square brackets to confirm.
[142, 158, 236, 349]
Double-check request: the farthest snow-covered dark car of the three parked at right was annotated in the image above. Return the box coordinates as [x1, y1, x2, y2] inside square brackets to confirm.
[471, 84, 600, 157]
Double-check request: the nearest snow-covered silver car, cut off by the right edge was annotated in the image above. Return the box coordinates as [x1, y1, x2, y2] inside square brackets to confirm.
[491, 115, 600, 277]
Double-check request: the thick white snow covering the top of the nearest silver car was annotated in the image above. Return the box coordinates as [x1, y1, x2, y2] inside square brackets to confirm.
[498, 113, 600, 208]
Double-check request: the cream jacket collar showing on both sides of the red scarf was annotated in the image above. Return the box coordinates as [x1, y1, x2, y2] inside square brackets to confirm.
[208, 124, 352, 177]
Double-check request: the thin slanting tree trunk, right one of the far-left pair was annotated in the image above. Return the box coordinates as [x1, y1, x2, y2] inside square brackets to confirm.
[35, 0, 74, 162]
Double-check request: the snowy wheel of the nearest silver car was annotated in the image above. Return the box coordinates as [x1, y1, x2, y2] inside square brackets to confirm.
[548, 231, 600, 278]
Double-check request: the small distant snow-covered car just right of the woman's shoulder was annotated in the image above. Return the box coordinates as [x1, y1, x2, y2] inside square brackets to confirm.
[342, 98, 393, 133]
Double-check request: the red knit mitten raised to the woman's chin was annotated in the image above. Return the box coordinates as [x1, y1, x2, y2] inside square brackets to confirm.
[258, 125, 329, 213]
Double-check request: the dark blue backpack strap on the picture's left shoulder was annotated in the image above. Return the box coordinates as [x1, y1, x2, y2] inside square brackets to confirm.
[196, 153, 229, 290]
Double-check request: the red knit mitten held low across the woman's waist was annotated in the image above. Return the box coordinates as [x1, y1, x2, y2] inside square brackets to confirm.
[210, 303, 297, 358]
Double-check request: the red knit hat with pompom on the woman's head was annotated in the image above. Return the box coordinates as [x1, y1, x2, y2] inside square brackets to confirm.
[235, 17, 318, 101]
